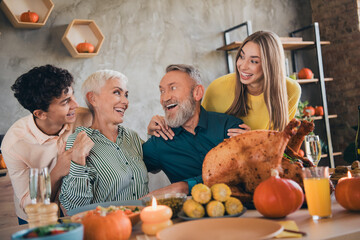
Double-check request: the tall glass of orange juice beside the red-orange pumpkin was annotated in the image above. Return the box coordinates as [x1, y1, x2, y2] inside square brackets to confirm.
[303, 167, 331, 220]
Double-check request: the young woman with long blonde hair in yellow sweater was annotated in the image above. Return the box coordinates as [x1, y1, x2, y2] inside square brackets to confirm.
[202, 31, 301, 133]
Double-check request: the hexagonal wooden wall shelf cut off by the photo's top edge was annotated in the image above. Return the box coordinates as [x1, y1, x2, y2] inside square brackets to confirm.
[0, 0, 54, 28]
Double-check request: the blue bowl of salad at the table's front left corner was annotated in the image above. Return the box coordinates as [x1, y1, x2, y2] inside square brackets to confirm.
[11, 223, 84, 240]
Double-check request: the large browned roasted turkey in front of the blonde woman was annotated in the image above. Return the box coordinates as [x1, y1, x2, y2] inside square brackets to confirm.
[202, 119, 314, 202]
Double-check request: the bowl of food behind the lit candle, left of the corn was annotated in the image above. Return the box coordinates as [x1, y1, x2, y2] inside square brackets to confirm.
[142, 193, 187, 218]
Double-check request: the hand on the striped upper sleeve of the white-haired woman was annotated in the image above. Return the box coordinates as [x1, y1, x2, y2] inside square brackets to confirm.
[71, 131, 94, 166]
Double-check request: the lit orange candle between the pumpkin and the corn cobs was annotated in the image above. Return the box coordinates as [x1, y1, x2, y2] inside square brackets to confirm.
[140, 197, 172, 235]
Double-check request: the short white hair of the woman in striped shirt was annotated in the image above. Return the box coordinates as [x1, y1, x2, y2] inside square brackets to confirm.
[81, 69, 128, 113]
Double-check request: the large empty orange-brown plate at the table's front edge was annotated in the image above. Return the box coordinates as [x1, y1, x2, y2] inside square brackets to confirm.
[156, 218, 283, 240]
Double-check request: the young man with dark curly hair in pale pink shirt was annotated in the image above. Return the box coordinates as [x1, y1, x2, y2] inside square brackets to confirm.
[1, 65, 91, 224]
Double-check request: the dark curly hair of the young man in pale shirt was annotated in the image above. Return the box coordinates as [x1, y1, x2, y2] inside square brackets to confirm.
[11, 65, 74, 113]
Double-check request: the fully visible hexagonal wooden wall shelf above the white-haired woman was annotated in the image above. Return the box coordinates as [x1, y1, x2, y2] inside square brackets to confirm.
[61, 19, 105, 58]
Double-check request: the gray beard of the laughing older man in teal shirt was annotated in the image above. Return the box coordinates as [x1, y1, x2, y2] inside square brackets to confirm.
[165, 96, 196, 128]
